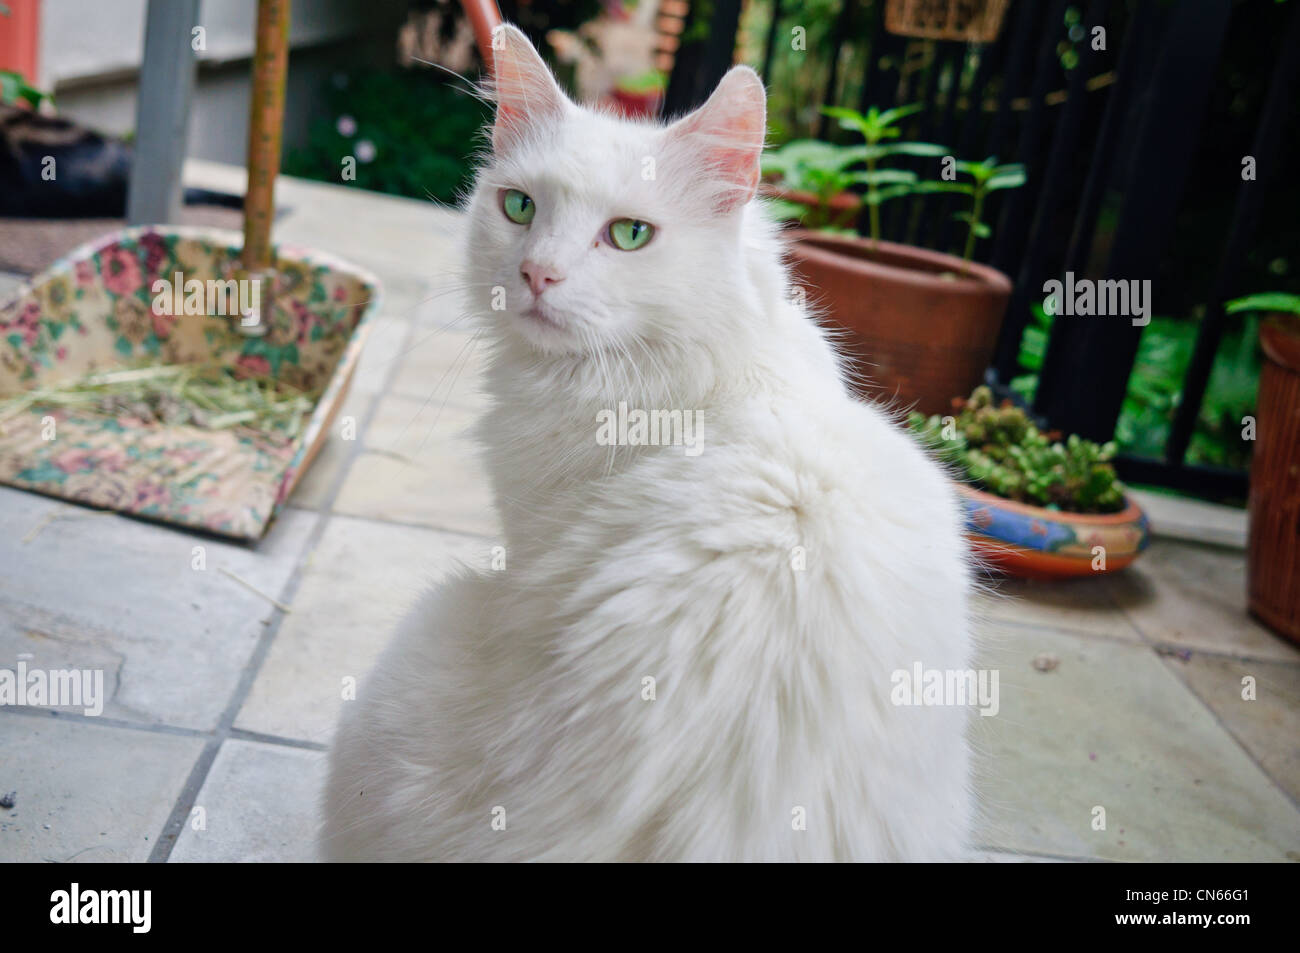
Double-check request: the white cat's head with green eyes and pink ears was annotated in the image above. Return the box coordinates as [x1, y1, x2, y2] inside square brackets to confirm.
[468, 26, 766, 354]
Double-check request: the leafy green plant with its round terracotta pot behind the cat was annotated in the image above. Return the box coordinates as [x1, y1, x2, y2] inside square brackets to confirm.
[764, 105, 1024, 413]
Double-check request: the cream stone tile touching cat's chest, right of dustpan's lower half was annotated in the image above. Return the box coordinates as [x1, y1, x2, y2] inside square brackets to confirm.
[334, 395, 501, 537]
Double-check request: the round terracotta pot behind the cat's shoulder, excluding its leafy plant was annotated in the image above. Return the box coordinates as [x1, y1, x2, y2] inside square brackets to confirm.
[790, 229, 1011, 413]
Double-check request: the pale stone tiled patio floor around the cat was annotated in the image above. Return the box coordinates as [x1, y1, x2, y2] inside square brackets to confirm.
[0, 165, 1300, 861]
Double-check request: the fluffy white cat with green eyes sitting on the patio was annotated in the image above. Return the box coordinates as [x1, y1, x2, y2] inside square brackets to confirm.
[324, 27, 971, 861]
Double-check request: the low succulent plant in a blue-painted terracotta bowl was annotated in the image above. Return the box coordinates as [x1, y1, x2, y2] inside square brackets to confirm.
[909, 386, 1151, 579]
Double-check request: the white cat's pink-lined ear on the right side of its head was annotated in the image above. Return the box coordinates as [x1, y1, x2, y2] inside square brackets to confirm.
[668, 66, 767, 212]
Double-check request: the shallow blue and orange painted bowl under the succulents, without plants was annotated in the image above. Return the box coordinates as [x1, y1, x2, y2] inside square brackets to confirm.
[957, 484, 1151, 579]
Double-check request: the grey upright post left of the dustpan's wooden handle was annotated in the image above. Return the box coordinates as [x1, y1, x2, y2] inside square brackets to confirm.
[126, 0, 199, 225]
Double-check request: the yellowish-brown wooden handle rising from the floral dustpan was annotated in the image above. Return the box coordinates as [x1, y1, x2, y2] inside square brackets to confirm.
[243, 0, 290, 272]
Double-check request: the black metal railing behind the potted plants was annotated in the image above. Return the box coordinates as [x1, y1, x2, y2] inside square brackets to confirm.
[666, 0, 1300, 498]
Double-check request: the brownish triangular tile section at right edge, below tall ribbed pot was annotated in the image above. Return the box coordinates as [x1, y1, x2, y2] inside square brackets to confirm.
[1165, 654, 1300, 803]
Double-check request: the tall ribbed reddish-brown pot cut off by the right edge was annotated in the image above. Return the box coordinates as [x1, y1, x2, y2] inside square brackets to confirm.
[1247, 322, 1300, 642]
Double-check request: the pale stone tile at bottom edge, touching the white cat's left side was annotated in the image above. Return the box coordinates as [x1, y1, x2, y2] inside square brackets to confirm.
[169, 738, 326, 863]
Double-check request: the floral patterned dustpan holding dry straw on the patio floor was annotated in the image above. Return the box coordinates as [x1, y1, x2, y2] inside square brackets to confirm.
[0, 226, 380, 540]
